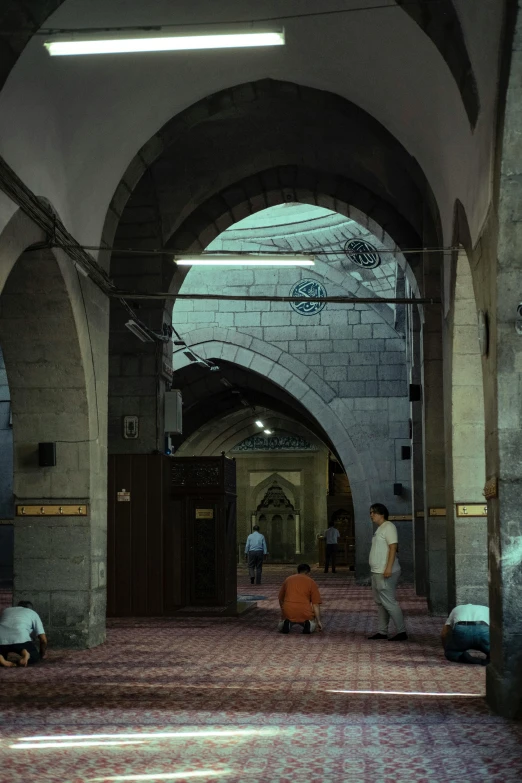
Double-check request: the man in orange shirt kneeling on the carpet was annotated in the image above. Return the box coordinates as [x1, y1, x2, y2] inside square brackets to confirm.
[278, 563, 323, 633]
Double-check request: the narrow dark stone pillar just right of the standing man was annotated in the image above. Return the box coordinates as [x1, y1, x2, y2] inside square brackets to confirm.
[421, 253, 448, 614]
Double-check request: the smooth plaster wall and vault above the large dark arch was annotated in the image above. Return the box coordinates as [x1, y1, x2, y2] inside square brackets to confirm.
[0, 0, 503, 250]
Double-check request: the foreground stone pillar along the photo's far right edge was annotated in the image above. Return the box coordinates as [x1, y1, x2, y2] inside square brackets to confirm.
[486, 2, 522, 718]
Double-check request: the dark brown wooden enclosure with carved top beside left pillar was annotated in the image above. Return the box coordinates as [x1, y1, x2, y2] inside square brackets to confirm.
[107, 454, 237, 617]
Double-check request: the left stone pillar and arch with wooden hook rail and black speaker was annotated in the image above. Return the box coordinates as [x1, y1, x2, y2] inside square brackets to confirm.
[0, 212, 108, 647]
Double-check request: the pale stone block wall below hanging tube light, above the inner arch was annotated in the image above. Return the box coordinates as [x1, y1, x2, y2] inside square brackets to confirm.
[173, 267, 411, 575]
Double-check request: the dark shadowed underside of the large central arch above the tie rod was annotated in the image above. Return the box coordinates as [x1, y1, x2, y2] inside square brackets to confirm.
[103, 79, 441, 268]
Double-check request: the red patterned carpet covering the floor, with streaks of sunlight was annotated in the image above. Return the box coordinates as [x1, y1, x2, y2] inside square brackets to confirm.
[0, 567, 522, 783]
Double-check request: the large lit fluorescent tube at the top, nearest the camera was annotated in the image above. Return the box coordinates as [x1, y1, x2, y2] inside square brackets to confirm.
[44, 30, 285, 57]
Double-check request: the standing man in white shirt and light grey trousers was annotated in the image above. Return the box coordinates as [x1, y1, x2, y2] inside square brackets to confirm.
[368, 503, 408, 642]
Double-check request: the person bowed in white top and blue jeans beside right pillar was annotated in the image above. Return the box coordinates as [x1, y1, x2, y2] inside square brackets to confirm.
[441, 604, 489, 666]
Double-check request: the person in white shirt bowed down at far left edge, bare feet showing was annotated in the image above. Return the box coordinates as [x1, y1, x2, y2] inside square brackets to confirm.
[0, 601, 47, 667]
